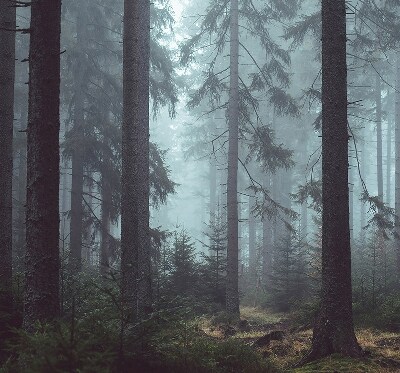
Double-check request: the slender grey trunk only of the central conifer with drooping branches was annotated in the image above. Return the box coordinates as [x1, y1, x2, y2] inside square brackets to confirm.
[226, 0, 239, 315]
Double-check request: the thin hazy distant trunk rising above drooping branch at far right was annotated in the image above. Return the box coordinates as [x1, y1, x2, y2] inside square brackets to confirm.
[375, 73, 383, 201]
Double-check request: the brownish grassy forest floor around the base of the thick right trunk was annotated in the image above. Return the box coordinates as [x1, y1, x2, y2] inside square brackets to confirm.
[200, 307, 400, 373]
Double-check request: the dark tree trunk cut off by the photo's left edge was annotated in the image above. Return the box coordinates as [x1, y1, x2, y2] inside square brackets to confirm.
[0, 0, 15, 338]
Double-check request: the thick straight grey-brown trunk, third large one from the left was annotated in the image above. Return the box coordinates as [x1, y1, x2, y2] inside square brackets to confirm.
[121, 0, 152, 317]
